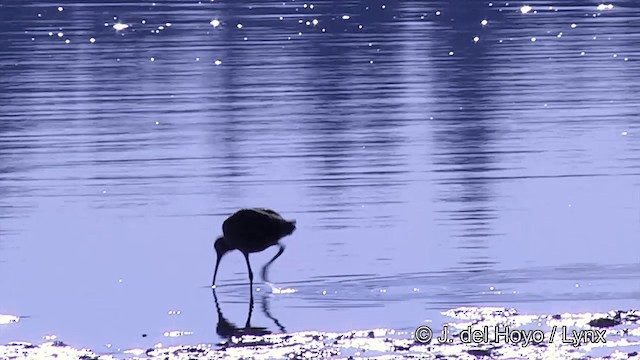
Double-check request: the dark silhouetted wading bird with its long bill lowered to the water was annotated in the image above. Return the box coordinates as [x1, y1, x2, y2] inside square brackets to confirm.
[211, 208, 296, 287]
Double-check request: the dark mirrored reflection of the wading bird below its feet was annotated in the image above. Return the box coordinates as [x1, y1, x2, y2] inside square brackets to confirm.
[211, 288, 287, 339]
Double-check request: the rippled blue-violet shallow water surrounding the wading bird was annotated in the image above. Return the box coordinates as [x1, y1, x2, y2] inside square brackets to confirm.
[0, 1, 640, 351]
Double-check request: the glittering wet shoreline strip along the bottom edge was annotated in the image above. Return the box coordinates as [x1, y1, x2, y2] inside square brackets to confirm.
[0, 307, 640, 360]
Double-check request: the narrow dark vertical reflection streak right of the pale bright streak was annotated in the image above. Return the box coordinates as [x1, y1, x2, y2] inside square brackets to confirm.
[433, 1, 499, 271]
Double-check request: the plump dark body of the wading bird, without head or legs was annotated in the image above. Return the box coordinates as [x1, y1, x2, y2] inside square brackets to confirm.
[222, 208, 296, 253]
